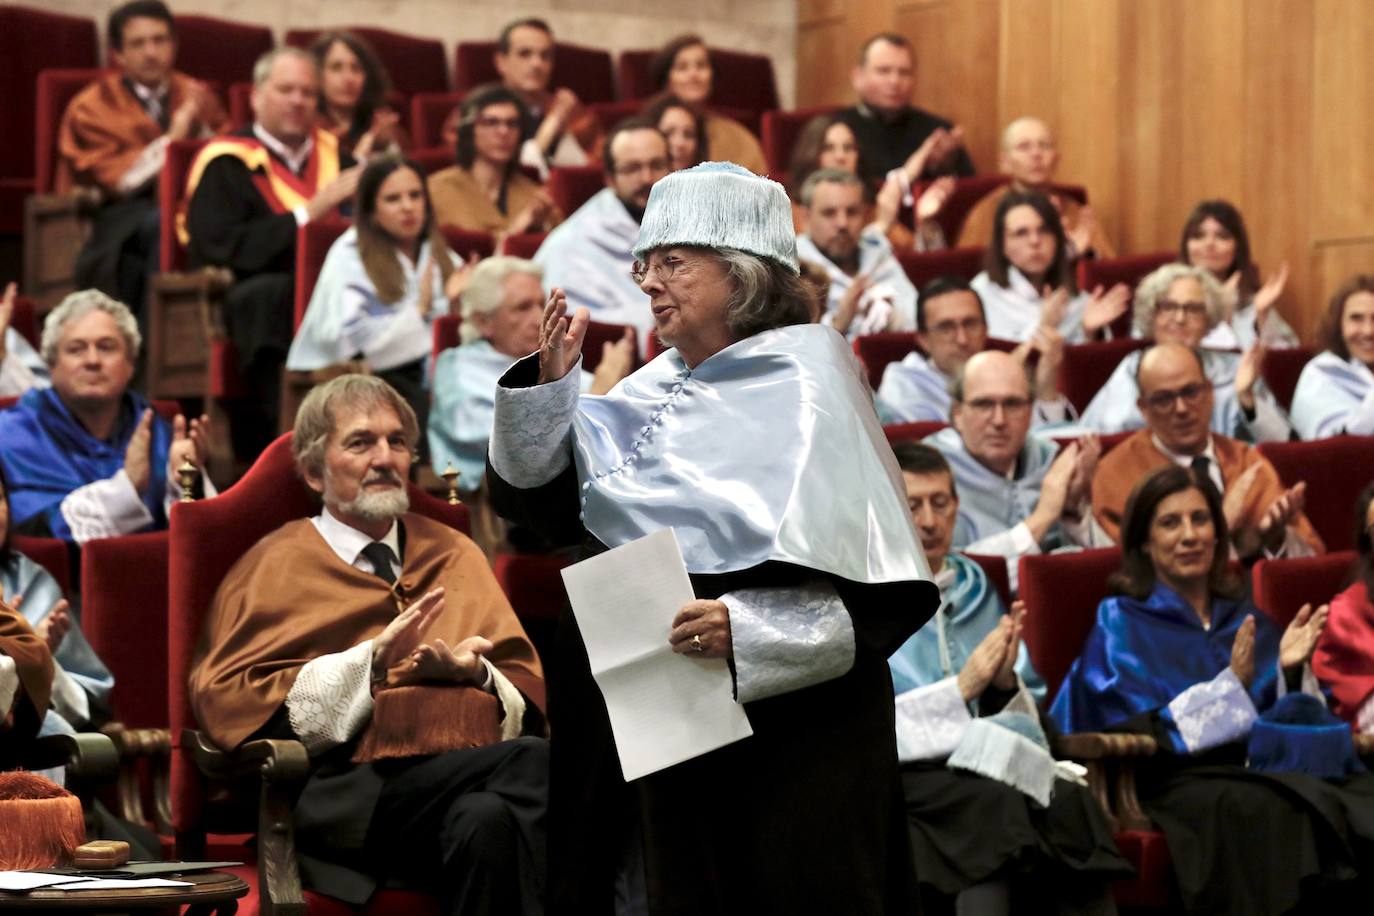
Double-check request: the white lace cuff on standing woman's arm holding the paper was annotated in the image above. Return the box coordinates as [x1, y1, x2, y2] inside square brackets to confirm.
[720, 580, 855, 703]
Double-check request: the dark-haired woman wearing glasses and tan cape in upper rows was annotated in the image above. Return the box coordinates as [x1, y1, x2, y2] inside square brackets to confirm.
[429, 85, 563, 240]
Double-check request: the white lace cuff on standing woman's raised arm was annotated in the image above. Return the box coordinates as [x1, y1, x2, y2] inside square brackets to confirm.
[491, 354, 581, 490]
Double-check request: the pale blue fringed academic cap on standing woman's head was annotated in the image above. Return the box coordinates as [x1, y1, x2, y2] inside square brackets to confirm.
[635, 162, 800, 273]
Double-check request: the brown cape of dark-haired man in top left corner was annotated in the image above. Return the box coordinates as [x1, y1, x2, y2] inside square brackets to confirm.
[55, 73, 229, 196]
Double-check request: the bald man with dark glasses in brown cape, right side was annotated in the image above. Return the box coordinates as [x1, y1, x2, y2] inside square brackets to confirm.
[1092, 343, 1325, 560]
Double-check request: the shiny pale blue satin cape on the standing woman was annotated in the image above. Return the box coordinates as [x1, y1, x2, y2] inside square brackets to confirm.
[573, 324, 930, 584]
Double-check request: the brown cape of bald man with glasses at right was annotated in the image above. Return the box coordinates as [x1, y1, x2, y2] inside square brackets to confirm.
[1092, 428, 1326, 553]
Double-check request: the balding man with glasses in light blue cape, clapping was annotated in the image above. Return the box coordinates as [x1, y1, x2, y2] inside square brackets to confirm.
[926, 350, 1102, 589]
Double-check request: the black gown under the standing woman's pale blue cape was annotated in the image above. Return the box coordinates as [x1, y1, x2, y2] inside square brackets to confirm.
[486, 357, 934, 916]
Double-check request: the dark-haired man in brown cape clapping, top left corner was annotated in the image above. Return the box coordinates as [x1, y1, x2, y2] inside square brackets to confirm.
[54, 0, 229, 313]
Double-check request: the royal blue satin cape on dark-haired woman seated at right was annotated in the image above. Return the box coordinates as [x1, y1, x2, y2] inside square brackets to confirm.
[1050, 582, 1279, 747]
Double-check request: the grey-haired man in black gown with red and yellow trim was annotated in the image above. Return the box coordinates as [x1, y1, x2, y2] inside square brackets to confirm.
[185, 47, 360, 460]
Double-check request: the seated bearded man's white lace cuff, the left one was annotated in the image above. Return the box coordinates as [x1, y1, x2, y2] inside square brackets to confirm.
[286, 640, 372, 755]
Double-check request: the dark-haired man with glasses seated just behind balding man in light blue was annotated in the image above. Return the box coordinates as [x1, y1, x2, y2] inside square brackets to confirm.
[878, 275, 1073, 427]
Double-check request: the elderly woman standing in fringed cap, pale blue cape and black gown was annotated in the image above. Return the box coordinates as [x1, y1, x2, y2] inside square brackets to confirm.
[488, 162, 938, 913]
